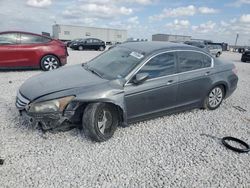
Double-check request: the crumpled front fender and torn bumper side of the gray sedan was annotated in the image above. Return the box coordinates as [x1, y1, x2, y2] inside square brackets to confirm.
[22, 79, 127, 130]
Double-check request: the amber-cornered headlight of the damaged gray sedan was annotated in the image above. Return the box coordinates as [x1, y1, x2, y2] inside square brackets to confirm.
[28, 96, 75, 112]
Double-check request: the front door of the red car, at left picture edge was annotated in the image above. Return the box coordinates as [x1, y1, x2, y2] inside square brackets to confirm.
[0, 33, 19, 68]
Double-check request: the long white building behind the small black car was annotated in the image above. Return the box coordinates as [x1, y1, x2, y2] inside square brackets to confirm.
[52, 24, 127, 43]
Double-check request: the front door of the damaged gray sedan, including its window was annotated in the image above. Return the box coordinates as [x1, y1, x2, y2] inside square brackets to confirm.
[125, 52, 178, 121]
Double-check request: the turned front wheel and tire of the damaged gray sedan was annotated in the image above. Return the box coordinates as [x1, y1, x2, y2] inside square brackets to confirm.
[82, 103, 119, 142]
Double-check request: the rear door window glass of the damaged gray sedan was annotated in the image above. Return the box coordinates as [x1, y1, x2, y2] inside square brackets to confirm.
[178, 51, 211, 72]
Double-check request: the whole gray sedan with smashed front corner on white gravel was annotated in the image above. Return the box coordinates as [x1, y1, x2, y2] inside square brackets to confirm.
[16, 42, 238, 142]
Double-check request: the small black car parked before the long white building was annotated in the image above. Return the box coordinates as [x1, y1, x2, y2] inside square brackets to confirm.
[69, 38, 106, 51]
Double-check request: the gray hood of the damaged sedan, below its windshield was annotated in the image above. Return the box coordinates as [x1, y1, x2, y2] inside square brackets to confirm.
[19, 65, 107, 101]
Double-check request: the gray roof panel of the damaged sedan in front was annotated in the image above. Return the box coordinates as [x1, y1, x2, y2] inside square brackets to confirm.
[119, 41, 205, 54]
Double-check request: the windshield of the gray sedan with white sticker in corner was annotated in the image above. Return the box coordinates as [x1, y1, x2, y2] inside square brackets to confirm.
[87, 47, 144, 80]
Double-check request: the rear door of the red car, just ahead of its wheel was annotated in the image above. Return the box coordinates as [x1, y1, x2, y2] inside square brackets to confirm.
[16, 33, 45, 67]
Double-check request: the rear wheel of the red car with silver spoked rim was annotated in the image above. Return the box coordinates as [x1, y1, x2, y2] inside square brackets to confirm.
[40, 55, 60, 71]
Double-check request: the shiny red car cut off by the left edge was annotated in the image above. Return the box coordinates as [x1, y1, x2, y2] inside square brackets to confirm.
[0, 31, 68, 71]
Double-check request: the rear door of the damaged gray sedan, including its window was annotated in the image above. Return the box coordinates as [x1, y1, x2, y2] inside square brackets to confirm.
[177, 51, 214, 106]
